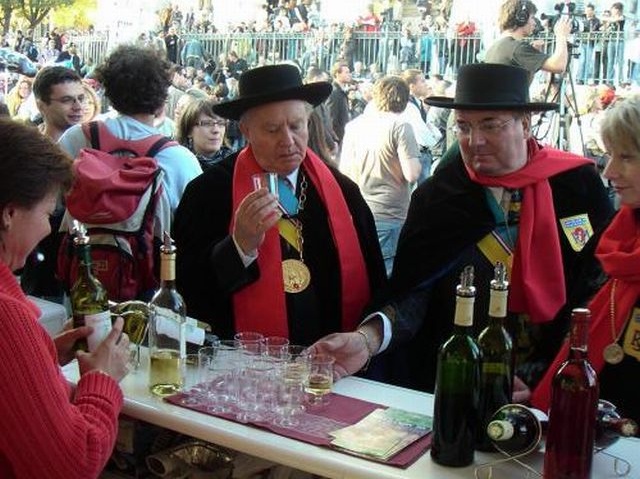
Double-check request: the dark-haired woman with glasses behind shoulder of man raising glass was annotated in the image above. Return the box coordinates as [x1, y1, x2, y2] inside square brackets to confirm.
[177, 99, 232, 170]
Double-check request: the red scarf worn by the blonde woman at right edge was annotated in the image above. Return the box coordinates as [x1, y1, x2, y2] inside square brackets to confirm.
[531, 206, 640, 411]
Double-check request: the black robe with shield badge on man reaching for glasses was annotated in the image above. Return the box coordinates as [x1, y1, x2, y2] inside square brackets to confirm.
[387, 155, 613, 391]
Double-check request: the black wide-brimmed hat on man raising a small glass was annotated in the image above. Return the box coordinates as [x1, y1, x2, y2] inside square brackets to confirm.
[213, 64, 332, 120]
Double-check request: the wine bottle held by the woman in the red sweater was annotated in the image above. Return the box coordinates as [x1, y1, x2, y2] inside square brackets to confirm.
[69, 220, 111, 351]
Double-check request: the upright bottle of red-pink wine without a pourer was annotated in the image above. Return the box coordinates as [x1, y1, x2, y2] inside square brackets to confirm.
[544, 308, 599, 479]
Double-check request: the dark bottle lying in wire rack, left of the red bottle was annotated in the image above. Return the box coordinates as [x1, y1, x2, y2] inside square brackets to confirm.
[486, 404, 546, 456]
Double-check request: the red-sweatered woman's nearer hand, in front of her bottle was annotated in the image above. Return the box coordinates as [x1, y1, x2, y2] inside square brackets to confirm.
[76, 316, 130, 382]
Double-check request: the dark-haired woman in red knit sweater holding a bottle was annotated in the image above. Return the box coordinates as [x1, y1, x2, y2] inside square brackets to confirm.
[0, 119, 129, 479]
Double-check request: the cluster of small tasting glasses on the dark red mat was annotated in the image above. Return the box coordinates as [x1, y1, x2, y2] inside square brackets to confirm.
[176, 332, 334, 427]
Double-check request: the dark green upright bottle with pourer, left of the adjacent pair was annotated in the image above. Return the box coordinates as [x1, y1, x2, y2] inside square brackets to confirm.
[431, 266, 480, 466]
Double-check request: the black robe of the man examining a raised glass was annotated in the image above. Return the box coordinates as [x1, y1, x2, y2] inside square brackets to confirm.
[173, 153, 386, 345]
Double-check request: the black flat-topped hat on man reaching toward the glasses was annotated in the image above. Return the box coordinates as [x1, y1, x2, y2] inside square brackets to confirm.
[424, 63, 558, 111]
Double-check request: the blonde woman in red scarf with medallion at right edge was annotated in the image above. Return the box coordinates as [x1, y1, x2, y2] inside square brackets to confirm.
[532, 96, 640, 422]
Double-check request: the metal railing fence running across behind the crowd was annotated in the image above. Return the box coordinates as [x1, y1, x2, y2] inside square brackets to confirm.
[72, 30, 640, 84]
